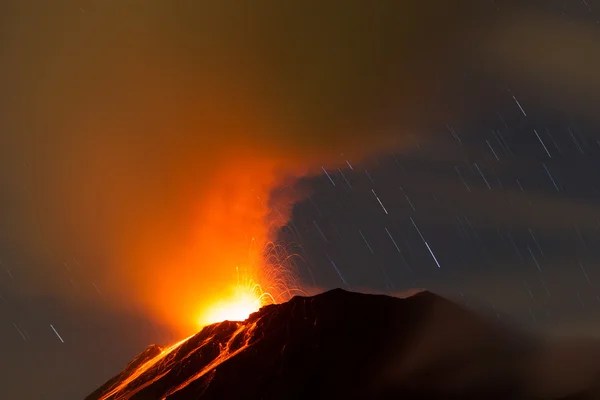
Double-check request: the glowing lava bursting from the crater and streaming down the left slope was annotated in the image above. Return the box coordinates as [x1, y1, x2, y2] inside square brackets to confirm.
[94, 242, 304, 400]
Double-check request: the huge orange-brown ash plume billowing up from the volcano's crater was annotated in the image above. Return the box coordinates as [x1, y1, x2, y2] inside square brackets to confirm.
[0, 0, 591, 332]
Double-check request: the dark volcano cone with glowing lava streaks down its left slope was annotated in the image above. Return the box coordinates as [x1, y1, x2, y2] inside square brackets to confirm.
[86, 289, 600, 400]
